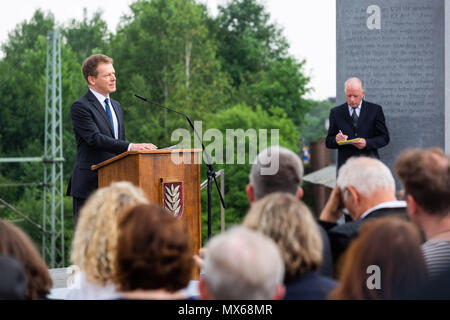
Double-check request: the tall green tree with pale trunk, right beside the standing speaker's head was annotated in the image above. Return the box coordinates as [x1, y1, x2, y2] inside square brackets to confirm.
[112, 0, 230, 144]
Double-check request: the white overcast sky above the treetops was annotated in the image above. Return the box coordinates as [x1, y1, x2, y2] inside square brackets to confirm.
[0, 0, 336, 100]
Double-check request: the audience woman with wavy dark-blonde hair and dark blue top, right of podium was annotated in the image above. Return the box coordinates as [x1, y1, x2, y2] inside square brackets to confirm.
[242, 193, 336, 300]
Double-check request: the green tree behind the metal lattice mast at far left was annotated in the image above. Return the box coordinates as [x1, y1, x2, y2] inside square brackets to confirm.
[0, 10, 86, 264]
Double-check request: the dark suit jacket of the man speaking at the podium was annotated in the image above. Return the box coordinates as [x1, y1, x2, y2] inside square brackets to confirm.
[67, 90, 129, 199]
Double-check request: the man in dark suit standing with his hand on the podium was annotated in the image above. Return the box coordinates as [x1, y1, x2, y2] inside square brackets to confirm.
[67, 54, 156, 225]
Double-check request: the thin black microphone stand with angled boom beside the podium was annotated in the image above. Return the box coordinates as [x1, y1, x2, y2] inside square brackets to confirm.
[134, 94, 226, 240]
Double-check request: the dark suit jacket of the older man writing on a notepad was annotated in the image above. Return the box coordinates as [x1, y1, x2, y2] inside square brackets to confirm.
[326, 100, 389, 169]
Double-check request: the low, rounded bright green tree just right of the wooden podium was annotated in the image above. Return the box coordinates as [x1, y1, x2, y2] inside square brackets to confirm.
[201, 104, 299, 240]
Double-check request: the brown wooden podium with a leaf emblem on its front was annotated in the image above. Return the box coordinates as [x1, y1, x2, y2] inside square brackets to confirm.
[91, 149, 202, 276]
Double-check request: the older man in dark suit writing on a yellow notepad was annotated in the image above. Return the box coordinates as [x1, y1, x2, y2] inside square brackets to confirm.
[326, 78, 389, 170]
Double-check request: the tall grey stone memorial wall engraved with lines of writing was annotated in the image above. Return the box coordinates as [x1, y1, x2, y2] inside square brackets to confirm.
[336, 0, 450, 179]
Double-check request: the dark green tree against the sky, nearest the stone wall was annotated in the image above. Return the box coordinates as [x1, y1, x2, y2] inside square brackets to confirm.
[215, 0, 309, 126]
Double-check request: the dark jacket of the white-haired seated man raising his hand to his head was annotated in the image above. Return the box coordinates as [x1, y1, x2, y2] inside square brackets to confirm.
[319, 208, 408, 270]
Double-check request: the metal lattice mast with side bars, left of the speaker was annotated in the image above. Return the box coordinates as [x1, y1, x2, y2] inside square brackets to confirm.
[0, 31, 65, 268]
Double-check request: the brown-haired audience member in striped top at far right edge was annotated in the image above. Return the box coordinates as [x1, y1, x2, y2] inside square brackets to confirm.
[395, 148, 450, 278]
